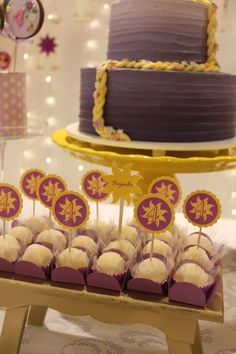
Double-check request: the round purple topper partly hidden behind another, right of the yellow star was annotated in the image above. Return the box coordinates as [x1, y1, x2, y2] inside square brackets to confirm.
[148, 177, 182, 207]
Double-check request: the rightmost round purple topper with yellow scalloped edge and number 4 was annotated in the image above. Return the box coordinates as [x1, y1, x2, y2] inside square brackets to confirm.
[183, 190, 221, 227]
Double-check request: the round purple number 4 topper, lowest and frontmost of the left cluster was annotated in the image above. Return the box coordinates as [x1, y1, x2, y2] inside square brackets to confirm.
[52, 191, 89, 230]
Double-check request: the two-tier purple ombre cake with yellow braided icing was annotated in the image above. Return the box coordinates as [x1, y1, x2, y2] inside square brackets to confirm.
[79, 0, 236, 142]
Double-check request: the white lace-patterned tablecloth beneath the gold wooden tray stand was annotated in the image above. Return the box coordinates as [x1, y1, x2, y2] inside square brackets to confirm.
[0, 206, 236, 354]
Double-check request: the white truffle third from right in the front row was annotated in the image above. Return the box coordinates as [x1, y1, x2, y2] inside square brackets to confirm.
[96, 252, 125, 275]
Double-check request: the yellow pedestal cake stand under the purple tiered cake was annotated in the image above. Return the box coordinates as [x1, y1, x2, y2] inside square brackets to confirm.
[52, 129, 236, 192]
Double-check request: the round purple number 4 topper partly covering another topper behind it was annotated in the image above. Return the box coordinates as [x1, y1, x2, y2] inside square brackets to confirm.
[134, 194, 175, 233]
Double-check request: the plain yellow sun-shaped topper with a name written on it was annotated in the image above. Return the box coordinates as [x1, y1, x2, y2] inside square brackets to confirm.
[104, 162, 143, 204]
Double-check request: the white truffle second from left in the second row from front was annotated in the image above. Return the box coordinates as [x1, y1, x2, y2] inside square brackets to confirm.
[36, 229, 66, 252]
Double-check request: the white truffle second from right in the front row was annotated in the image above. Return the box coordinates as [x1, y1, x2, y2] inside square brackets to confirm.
[133, 257, 167, 283]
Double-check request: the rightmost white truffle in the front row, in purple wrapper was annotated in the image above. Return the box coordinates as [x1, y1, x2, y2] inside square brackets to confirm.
[174, 263, 209, 288]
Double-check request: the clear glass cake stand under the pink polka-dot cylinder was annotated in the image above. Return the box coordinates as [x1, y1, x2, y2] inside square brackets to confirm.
[0, 119, 47, 182]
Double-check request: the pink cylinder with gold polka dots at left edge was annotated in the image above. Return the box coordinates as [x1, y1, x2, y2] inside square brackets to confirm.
[0, 73, 27, 136]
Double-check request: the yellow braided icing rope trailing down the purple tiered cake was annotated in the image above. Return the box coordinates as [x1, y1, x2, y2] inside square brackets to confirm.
[93, 0, 220, 141]
